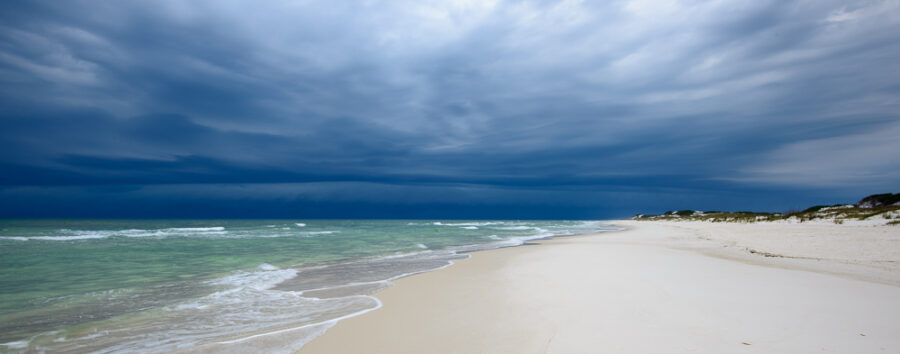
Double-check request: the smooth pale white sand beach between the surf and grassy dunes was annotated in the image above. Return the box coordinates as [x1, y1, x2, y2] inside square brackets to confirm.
[300, 221, 900, 353]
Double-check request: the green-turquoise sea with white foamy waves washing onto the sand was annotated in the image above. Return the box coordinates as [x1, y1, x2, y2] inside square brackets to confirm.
[0, 219, 615, 353]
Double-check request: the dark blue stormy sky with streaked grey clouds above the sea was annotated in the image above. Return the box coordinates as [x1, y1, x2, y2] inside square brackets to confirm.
[0, 0, 900, 219]
